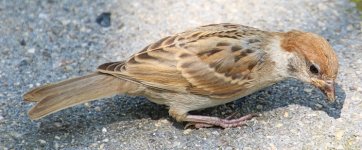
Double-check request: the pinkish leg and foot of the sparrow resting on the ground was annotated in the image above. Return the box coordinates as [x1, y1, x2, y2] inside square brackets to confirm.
[184, 114, 255, 128]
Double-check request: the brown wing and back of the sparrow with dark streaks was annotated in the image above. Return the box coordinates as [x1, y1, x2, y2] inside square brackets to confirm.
[98, 24, 268, 98]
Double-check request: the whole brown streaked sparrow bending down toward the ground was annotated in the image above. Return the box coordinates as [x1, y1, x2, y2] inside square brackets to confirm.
[24, 23, 338, 128]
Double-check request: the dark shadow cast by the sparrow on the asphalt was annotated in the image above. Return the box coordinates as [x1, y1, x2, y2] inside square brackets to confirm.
[33, 80, 346, 132]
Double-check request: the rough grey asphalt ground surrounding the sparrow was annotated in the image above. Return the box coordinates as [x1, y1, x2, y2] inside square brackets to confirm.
[0, 0, 362, 150]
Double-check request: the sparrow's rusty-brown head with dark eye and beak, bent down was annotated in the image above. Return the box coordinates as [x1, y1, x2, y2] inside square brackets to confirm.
[281, 30, 339, 103]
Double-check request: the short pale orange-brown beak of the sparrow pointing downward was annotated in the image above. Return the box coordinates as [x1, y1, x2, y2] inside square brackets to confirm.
[312, 79, 336, 103]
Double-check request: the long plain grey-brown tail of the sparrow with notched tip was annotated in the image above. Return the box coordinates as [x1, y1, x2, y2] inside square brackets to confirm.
[24, 73, 139, 120]
